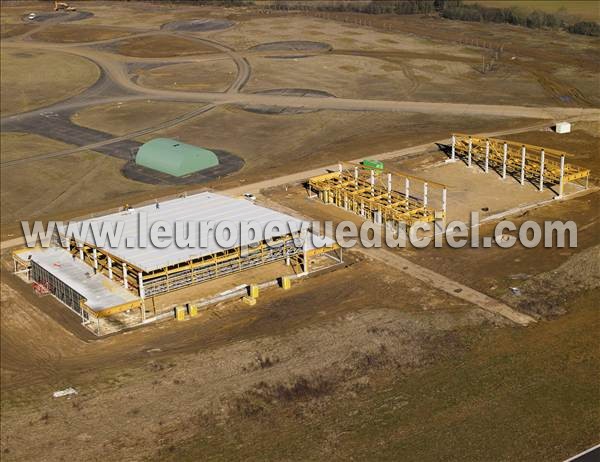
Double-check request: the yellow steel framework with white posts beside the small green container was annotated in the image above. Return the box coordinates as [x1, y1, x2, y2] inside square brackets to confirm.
[307, 162, 447, 227]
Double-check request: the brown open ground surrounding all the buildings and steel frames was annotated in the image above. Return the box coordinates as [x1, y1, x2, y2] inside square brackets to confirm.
[0, 1, 600, 462]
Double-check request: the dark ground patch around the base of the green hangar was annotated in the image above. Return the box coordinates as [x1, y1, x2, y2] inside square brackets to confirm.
[121, 148, 244, 185]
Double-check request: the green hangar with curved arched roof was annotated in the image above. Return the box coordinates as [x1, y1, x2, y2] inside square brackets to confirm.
[135, 138, 219, 176]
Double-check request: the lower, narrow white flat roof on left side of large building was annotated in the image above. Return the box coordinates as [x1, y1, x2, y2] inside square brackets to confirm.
[26, 247, 139, 311]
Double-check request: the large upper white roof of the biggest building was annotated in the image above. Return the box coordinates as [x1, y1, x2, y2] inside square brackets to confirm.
[63, 192, 333, 272]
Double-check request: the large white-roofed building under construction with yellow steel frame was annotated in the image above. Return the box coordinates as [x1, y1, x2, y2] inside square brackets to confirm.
[13, 192, 341, 330]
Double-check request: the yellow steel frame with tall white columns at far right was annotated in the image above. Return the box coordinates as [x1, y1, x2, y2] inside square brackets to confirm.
[450, 133, 590, 198]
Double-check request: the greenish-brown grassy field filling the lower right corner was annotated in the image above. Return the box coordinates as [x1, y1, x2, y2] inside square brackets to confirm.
[159, 292, 600, 461]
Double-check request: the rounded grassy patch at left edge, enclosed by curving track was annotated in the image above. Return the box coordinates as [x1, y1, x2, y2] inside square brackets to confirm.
[0, 49, 100, 116]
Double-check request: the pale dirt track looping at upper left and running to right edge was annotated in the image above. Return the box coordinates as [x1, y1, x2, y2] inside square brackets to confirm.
[1, 22, 600, 167]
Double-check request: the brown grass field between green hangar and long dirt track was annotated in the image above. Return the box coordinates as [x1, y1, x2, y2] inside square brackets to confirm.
[140, 107, 544, 189]
